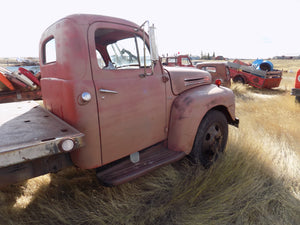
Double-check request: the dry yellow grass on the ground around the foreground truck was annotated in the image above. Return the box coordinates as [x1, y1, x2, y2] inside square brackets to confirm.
[0, 60, 300, 225]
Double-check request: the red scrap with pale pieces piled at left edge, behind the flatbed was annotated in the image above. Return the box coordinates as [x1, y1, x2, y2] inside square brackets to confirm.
[0, 66, 42, 103]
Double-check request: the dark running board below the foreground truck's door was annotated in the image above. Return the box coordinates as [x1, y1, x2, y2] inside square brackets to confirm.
[96, 144, 186, 186]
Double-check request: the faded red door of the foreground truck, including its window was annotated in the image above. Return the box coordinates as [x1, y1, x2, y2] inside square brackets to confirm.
[88, 22, 166, 164]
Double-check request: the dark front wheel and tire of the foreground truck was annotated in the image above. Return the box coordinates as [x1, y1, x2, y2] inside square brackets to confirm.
[189, 110, 228, 169]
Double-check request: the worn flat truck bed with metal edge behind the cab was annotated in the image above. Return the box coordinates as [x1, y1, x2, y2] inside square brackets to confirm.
[0, 101, 83, 168]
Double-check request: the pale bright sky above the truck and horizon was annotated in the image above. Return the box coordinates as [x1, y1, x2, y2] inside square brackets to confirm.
[0, 0, 300, 58]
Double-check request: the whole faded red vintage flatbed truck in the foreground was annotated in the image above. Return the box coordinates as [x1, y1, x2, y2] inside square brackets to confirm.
[0, 14, 238, 185]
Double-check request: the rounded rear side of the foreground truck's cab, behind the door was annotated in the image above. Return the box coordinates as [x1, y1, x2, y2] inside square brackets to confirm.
[40, 15, 102, 169]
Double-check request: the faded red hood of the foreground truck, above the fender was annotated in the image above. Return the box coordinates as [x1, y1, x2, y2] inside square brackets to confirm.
[164, 66, 211, 95]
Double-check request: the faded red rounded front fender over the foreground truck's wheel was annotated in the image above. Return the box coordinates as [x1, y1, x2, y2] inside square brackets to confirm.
[168, 85, 235, 154]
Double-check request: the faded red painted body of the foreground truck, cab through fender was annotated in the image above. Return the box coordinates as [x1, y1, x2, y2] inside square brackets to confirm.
[40, 15, 235, 169]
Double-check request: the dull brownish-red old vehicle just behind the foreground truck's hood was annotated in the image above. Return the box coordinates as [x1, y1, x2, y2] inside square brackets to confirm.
[196, 62, 231, 87]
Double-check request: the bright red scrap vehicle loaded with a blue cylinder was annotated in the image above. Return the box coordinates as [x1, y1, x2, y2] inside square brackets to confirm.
[228, 60, 282, 89]
